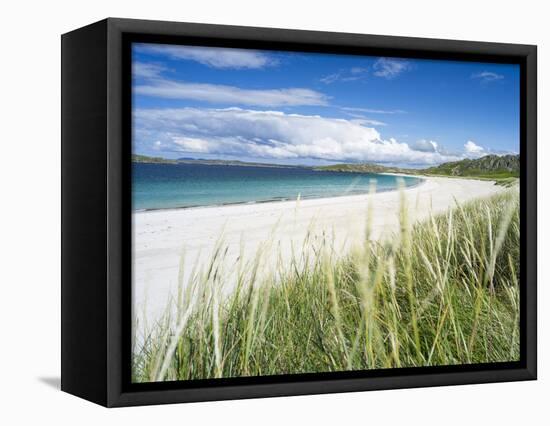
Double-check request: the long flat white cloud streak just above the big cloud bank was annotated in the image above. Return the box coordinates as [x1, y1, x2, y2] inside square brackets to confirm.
[134, 79, 328, 107]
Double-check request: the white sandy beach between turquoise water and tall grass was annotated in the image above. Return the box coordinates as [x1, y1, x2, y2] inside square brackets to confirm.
[133, 177, 503, 321]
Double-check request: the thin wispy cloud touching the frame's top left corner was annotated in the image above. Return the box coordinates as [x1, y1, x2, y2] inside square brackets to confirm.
[136, 44, 277, 69]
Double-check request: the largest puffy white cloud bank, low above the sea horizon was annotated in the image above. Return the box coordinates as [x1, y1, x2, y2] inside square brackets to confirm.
[134, 108, 466, 166]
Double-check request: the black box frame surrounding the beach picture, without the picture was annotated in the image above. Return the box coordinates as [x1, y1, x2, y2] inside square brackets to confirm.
[61, 18, 537, 407]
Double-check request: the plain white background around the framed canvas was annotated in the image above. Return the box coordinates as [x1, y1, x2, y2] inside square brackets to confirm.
[0, 0, 550, 426]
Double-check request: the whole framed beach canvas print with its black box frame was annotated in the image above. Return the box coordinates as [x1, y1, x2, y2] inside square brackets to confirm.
[62, 19, 536, 406]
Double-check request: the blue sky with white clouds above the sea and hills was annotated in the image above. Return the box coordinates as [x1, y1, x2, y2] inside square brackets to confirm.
[132, 44, 519, 167]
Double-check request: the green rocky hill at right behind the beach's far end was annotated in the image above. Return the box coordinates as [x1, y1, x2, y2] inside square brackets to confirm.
[315, 155, 519, 179]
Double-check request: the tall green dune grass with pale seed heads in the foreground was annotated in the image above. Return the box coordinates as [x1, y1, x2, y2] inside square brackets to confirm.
[133, 188, 519, 382]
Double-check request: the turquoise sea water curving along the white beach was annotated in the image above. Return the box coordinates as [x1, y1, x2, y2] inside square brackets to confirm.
[132, 163, 421, 210]
